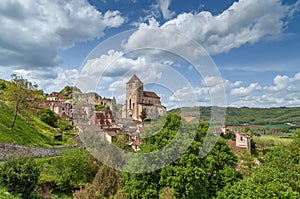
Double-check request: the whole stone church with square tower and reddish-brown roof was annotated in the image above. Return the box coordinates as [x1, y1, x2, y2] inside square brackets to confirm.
[122, 75, 166, 121]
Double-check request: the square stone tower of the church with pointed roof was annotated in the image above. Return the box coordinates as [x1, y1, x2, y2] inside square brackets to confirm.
[125, 75, 144, 120]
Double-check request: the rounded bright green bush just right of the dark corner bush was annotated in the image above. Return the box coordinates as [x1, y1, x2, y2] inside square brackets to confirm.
[53, 148, 93, 191]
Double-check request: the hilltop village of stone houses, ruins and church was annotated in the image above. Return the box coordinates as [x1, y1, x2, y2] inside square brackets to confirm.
[41, 75, 166, 150]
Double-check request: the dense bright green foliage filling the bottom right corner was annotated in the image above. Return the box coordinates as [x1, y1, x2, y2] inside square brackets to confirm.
[217, 130, 300, 199]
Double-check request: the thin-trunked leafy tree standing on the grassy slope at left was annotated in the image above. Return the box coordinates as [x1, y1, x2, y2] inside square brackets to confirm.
[1, 74, 41, 129]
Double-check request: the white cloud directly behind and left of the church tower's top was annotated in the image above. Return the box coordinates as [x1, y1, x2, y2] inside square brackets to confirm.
[77, 50, 164, 92]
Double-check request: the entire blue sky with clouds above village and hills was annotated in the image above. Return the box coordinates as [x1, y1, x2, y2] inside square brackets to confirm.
[0, 0, 300, 109]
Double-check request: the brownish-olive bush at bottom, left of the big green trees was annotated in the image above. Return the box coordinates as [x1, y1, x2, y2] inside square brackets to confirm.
[73, 165, 120, 199]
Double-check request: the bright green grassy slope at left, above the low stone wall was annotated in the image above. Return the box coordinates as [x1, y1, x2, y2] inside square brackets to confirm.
[0, 102, 62, 147]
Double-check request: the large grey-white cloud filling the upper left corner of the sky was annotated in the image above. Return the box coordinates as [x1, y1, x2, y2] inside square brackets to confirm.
[0, 0, 125, 68]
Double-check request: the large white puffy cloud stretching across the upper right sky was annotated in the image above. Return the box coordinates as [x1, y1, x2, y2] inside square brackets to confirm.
[126, 0, 294, 54]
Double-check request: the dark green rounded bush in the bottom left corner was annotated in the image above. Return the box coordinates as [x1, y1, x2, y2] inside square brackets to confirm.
[0, 156, 40, 198]
